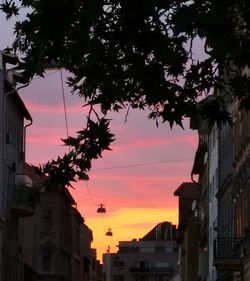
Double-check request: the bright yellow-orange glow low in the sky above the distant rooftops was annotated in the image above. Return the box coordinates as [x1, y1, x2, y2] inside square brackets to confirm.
[83, 207, 178, 260]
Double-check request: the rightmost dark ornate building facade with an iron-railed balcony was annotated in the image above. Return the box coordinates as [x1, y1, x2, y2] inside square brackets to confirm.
[214, 97, 250, 281]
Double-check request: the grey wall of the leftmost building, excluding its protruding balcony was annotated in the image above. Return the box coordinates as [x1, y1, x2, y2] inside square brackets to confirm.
[0, 52, 31, 281]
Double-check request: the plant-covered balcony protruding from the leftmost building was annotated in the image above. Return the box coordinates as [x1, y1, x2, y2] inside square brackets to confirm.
[11, 185, 38, 217]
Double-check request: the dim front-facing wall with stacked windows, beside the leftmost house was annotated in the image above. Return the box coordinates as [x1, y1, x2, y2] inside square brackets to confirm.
[21, 188, 73, 281]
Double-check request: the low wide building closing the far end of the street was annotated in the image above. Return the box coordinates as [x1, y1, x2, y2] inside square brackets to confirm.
[103, 222, 178, 281]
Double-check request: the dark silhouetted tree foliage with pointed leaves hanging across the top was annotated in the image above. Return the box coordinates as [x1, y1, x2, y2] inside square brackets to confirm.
[1, 0, 250, 188]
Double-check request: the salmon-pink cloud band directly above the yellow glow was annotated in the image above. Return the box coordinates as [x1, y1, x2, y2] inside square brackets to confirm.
[74, 174, 185, 210]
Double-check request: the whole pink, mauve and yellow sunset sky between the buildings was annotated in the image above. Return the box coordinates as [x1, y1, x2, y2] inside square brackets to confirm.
[0, 16, 197, 258]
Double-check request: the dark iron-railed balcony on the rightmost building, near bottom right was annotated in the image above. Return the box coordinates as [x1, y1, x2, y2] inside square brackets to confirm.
[213, 237, 244, 271]
